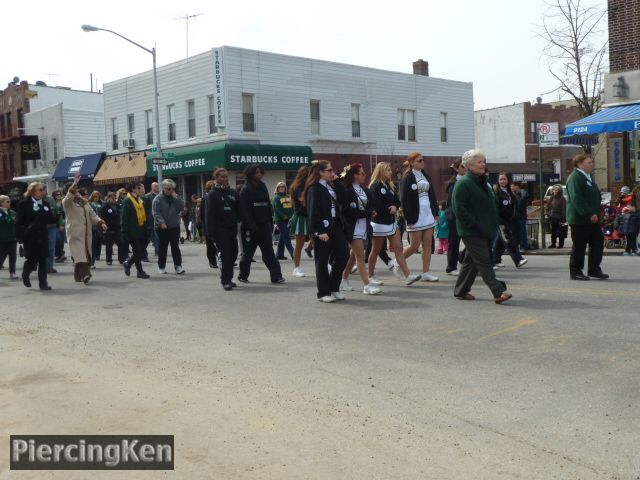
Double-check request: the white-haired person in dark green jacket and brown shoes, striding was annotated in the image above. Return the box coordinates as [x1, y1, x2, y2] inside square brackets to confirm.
[451, 150, 512, 304]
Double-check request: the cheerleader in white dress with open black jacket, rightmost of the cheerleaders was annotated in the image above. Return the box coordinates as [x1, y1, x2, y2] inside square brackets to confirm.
[400, 152, 438, 282]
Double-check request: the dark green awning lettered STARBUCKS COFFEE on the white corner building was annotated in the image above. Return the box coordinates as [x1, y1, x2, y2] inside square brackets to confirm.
[147, 143, 313, 177]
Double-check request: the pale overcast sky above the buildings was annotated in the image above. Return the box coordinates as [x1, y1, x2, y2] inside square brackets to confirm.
[0, 0, 605, 110]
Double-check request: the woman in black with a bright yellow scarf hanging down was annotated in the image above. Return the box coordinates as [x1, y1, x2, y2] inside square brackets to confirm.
[120, 182, 149, 278]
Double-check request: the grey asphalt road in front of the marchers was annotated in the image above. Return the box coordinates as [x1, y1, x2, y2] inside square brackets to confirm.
[0, 245, 640, 480]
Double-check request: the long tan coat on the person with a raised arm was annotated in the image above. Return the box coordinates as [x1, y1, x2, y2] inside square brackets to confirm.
[62, 188, 104, 264]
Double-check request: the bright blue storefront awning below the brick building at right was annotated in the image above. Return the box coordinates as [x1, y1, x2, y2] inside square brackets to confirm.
[564, 103, 640, 136]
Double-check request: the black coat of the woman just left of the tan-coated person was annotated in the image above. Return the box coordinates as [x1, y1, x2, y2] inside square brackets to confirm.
[16, 197, 55, 258]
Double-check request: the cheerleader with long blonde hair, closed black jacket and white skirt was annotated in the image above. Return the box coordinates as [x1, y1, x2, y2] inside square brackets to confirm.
[369, 162, 422, 285]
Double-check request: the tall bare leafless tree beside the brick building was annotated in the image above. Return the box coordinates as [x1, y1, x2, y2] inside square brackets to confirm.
[537, 0, 608, 117]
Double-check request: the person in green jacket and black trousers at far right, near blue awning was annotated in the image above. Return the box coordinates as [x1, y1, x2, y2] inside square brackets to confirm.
[567, 153, 609, 280]
